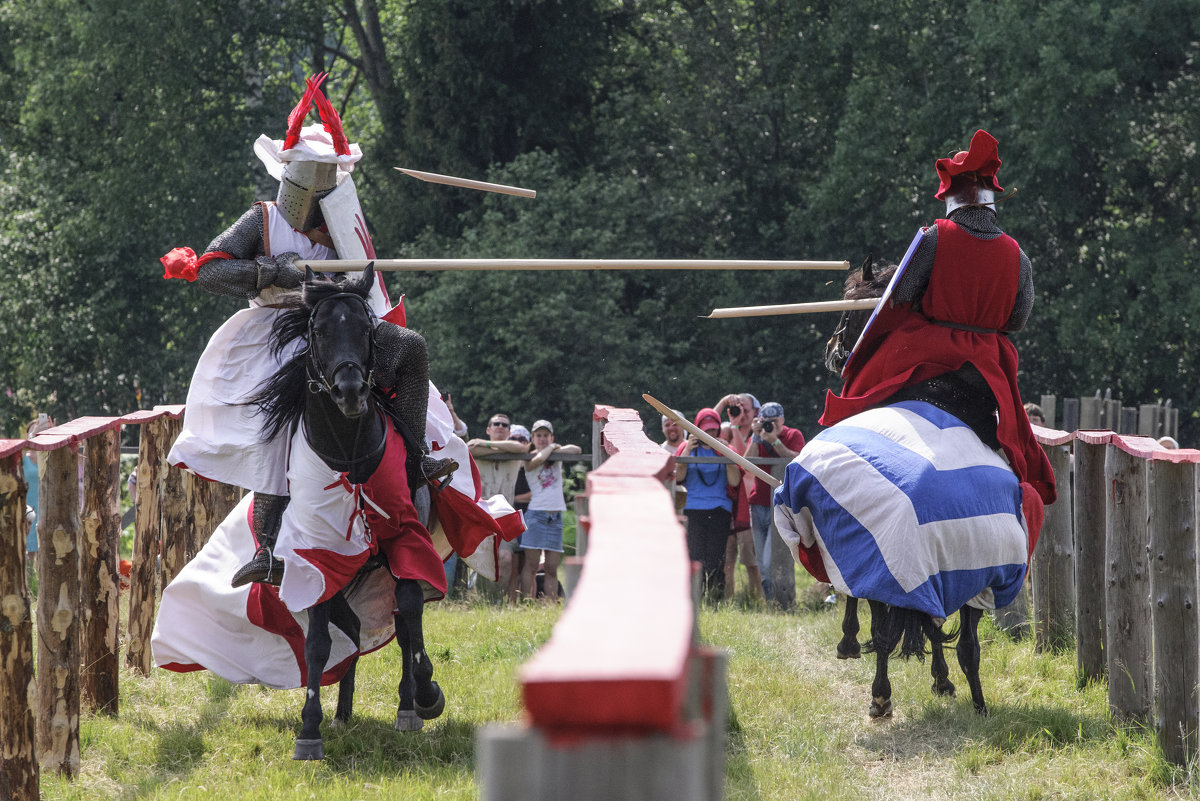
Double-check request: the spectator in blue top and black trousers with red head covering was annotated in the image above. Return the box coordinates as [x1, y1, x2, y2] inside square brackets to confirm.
[676, 408, 742, 602]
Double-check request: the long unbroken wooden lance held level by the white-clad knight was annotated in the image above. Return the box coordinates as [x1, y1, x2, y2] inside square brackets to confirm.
[296, 259, 850, 272]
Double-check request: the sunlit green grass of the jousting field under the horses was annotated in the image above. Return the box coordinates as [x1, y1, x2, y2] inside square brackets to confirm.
[42, 573, 1200, 801]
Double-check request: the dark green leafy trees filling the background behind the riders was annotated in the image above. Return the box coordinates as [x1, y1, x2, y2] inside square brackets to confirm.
[0, 0, 1200, 445]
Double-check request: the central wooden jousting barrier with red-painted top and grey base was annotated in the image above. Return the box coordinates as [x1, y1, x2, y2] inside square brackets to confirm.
[478, 405, 728, 801]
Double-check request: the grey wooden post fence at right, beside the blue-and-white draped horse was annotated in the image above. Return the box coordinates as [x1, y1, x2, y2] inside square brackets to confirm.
[1031, 426, 1200, 765]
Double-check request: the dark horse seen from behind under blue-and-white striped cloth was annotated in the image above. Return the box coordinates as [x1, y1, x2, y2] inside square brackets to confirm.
[811, 257, 994, 718]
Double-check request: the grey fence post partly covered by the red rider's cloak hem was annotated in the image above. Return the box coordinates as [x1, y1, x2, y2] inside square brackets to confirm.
[1032, 445, 1075, 651]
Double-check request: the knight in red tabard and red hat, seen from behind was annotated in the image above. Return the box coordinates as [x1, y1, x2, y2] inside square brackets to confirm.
[821, 131, 1056, 532]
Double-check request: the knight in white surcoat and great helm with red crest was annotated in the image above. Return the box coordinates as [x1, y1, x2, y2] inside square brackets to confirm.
[162, 76, 457, 586]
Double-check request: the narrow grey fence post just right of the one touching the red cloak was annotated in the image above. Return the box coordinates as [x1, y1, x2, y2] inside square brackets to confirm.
[1073, 438, 1108, 681]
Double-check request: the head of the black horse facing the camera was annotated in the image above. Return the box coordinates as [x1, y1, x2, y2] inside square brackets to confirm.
[304, 265, 376, 418]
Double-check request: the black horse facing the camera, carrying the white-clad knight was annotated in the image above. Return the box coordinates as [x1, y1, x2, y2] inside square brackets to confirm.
[252, 266, 445, 759]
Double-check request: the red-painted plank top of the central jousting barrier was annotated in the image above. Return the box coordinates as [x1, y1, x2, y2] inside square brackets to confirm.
[521, 405, 695, 735]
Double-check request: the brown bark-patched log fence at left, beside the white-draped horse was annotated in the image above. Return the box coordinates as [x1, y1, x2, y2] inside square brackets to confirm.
[0, 406, 241, 801]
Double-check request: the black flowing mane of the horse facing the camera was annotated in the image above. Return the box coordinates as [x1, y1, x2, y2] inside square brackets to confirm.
[242, 272, 373, 442]
